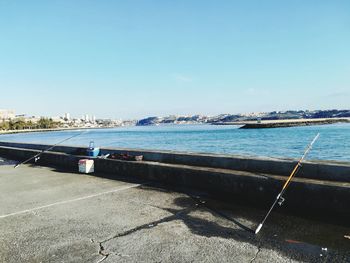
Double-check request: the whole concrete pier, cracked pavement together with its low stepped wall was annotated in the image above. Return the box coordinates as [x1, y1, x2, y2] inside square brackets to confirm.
[0, 142, 350, 262]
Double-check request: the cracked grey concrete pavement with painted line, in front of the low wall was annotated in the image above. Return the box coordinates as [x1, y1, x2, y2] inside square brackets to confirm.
[0, 159, 350, 262]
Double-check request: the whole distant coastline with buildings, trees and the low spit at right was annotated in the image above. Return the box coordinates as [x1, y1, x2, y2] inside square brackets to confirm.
[0, 110, 350, 135]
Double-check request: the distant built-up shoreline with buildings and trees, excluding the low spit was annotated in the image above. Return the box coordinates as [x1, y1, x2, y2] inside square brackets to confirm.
[0, 109, 350, 130]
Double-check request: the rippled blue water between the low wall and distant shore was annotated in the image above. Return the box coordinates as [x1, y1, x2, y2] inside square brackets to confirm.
[0, 123, 350, 162]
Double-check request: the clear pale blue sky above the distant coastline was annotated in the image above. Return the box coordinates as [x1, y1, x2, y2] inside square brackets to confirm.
[0, 0, 350, 118]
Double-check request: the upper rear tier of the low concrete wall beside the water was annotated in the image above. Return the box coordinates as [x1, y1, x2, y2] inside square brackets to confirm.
[0, 142, 350, 182]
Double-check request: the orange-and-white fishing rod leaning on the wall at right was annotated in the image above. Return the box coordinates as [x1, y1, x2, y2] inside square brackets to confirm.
[255, 133, 320, 234]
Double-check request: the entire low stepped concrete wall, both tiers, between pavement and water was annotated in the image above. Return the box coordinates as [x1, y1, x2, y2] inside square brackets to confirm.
[0, 142, 350, 224]
